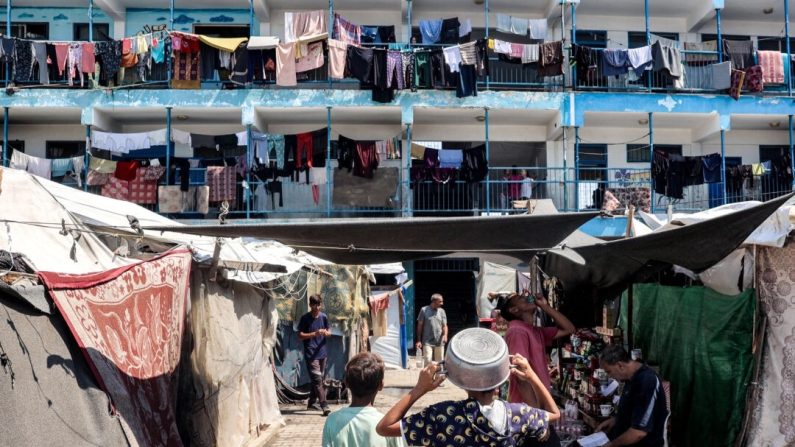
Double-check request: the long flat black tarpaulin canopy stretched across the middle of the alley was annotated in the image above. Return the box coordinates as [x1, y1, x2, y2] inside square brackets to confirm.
[145, 213, 596, 264]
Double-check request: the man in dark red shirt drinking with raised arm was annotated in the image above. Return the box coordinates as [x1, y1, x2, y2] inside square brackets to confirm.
[500, 293, 575, 446]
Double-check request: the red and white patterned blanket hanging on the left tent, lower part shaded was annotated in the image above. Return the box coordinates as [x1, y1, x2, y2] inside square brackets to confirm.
[39, 250, 191, 446]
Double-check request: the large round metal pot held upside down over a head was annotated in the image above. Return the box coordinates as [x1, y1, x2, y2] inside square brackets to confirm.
[444, 328, 511, 391]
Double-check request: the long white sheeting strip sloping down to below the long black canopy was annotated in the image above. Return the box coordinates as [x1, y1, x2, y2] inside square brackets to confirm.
[37, 179, 328, 284]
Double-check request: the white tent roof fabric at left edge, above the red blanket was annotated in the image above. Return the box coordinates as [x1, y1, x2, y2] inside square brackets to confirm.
[0, 168, 132, 274]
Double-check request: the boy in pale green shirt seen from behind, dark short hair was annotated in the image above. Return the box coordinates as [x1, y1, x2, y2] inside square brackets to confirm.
[323, 352, 401, 447]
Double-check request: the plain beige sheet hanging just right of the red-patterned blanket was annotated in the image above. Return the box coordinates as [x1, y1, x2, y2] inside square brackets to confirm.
[187, 269, 284, 446]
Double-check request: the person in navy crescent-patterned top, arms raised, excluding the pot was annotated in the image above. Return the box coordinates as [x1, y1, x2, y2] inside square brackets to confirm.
[376, 329, 560, 447]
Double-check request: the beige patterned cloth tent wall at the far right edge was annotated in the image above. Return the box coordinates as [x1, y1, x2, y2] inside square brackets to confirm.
[747, 243, 795, 446]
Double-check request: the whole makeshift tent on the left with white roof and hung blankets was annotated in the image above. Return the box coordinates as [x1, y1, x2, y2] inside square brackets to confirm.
[0, 169, 322, 445]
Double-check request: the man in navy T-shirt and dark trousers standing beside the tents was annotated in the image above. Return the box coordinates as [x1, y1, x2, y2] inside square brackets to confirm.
[298, 295, 331, 416]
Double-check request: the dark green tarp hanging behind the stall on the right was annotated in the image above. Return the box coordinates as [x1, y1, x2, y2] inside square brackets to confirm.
[621, 284, 756, 447]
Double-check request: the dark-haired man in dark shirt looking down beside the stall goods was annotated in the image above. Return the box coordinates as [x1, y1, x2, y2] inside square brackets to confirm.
[596, 345, 668, 447]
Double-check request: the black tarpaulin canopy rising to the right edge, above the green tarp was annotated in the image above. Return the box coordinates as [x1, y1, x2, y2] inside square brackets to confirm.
[541, 194, 793, 290]
